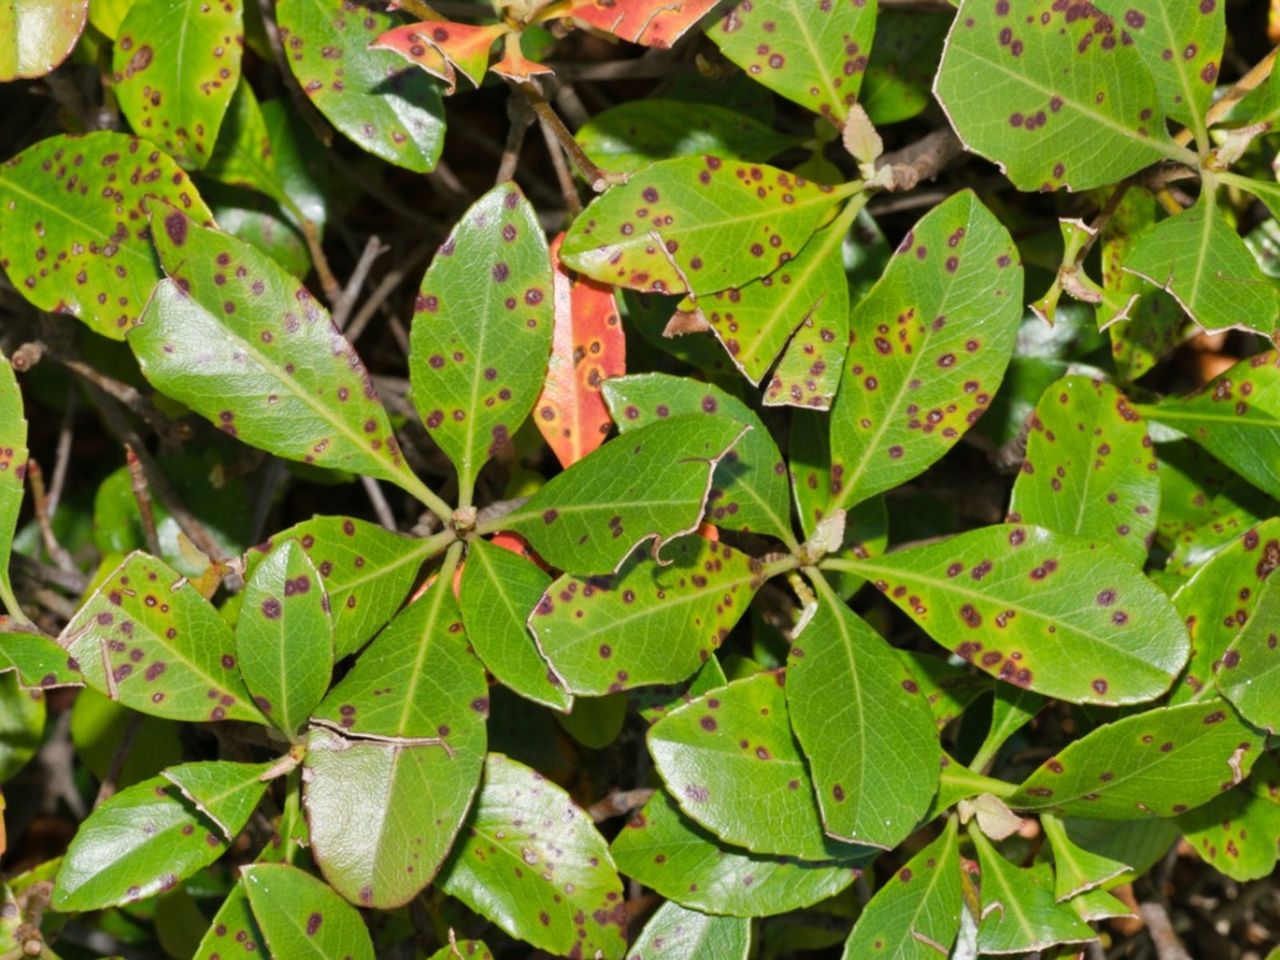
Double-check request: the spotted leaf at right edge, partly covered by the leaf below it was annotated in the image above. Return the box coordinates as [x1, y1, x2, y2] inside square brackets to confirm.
[1170, 517, 1280, 703]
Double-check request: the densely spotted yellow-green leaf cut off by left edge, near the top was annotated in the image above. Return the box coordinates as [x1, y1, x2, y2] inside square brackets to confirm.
[0, 131, 211, 340]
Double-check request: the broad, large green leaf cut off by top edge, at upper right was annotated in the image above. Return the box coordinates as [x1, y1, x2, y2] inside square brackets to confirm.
[934, 0, 1182, 191]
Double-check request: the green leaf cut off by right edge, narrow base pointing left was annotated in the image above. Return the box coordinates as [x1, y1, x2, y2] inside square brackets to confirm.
[1142, 350, 1280, 497]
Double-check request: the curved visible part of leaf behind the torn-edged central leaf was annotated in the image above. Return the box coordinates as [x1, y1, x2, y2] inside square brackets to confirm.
[604, 374, 792, 543]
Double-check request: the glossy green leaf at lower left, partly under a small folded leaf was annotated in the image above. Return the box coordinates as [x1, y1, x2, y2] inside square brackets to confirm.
[52, 777, 227, 913]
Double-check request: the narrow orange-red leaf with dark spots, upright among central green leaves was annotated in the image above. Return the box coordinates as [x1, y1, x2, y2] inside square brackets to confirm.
[534, 234, 626, 467]
